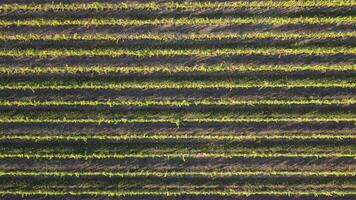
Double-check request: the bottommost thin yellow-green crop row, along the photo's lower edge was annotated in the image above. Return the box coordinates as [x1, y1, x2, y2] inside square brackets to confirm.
[0, 189, 356, 197]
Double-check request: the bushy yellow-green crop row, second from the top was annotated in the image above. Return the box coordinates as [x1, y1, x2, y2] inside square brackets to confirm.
[0, 16, 356, 26]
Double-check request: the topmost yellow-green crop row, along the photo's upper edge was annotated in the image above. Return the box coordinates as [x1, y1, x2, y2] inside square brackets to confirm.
[0, 0, 356, 11]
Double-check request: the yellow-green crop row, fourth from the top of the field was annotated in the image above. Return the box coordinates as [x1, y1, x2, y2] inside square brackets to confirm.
[0, 46, 356, 57]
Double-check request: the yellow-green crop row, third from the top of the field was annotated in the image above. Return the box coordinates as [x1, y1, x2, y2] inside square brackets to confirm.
[0, 31, 356, 41]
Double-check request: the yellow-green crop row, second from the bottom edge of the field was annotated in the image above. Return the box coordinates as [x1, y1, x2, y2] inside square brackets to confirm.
[0, 171, 356, 177]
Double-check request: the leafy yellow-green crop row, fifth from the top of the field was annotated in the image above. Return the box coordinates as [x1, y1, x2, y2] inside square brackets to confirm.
[0, 64, 356, 75]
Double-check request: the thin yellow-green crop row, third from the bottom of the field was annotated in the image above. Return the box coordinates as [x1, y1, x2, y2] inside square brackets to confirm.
[0, 152, 356, 160]
